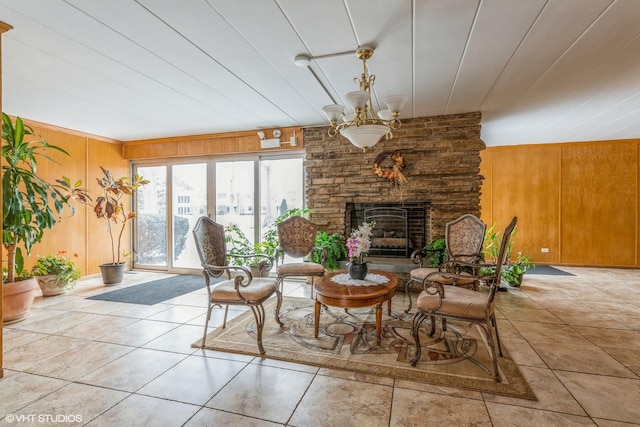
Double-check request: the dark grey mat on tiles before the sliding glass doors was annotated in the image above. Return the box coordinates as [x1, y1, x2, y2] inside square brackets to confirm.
[87, 274, 212, 305]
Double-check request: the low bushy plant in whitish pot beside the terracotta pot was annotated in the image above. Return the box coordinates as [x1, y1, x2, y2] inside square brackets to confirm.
[31, 251, 82, 297]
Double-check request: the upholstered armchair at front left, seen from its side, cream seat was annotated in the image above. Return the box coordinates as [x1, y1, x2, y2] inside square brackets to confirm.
[193, 216, 283, 355]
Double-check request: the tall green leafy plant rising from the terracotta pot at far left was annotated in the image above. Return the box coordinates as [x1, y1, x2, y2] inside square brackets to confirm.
[2, 112, 90, 282]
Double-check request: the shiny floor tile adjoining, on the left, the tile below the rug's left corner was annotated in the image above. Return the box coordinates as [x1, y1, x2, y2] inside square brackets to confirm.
[78, 348, 186, 392]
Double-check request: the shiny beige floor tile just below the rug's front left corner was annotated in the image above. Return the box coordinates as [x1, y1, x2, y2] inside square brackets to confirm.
[137, 356, 247, 406]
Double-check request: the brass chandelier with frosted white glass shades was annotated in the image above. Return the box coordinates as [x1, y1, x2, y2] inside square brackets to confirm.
[322, 46, 409, 151]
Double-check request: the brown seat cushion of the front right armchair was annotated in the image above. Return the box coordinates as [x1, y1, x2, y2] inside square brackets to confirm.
[416, 286, 495, 320]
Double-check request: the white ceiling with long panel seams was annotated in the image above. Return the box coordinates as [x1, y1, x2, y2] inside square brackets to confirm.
[0, 0, 640, 146]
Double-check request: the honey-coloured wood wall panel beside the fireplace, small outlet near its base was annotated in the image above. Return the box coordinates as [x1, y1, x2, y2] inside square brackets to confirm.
[487, 145, 560, 263]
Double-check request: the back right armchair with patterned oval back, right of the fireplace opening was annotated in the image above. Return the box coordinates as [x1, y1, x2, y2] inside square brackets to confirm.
[405, 214, 487, 313]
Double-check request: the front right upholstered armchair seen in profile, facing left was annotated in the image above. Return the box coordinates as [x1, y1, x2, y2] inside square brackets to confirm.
[410, 217, 517, 382]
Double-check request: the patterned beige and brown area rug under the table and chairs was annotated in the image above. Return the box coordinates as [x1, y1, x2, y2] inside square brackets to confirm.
[192, 298, 537, 400]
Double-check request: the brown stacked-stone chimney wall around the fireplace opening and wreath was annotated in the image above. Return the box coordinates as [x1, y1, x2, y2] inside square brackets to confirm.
[304, 112, 485, 241]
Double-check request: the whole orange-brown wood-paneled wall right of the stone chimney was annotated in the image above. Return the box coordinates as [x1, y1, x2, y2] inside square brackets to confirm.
[480, 140, 640, 267]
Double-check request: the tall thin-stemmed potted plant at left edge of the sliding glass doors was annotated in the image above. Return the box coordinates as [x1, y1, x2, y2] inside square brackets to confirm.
[93, 166, 149, 285]
